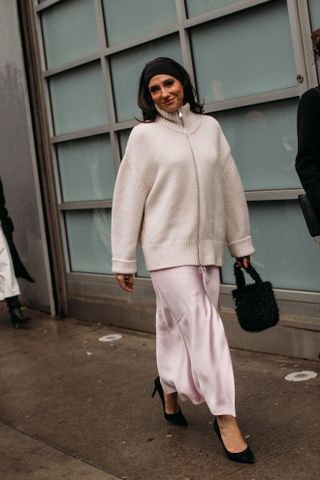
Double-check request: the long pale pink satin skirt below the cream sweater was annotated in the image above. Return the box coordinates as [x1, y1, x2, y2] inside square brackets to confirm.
[150, 266, 236, 417]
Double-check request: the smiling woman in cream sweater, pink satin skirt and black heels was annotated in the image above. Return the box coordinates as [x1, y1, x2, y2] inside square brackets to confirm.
[112, 58, 254, 463]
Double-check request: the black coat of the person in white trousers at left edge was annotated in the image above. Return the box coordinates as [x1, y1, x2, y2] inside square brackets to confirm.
[0, 178, 34, 282]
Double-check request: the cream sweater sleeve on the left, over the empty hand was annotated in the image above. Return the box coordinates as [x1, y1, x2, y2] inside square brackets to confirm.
[111, 157, 148, 274]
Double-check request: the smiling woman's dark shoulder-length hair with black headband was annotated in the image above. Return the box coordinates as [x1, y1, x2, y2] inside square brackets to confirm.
[138, 57, 204, 122]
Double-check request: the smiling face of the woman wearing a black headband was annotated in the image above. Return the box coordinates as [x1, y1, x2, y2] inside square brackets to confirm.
[148, 75, 184, 113]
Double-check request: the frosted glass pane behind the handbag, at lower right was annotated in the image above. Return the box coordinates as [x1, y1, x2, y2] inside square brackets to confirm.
[222, 201, 320, 291]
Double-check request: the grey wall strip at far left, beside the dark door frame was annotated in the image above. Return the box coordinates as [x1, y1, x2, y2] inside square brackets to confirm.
[0, 0, 53, 313]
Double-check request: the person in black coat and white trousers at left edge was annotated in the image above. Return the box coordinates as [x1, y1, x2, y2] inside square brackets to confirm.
[0, 178, 34, 328]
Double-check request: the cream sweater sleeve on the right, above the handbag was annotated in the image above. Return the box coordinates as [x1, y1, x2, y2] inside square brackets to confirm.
[219, 124, 254, 257]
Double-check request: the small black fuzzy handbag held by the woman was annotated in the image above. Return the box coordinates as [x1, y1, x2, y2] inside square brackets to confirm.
[232, 264, 279, 332]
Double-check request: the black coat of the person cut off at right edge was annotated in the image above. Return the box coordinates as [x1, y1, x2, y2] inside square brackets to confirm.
[296, 87, 320, 219]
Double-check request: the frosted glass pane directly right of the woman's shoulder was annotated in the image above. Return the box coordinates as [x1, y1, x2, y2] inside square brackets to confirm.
[214, 100, 300, 190]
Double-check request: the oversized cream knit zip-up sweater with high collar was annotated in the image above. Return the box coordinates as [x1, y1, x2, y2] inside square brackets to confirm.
[111, 104, 254, 274]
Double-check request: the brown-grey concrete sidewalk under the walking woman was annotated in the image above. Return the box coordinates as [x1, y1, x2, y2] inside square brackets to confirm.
[0, 308, 320, 480]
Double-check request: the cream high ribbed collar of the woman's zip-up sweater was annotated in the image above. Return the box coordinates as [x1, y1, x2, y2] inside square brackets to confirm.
[155, 103, 201, 133]
